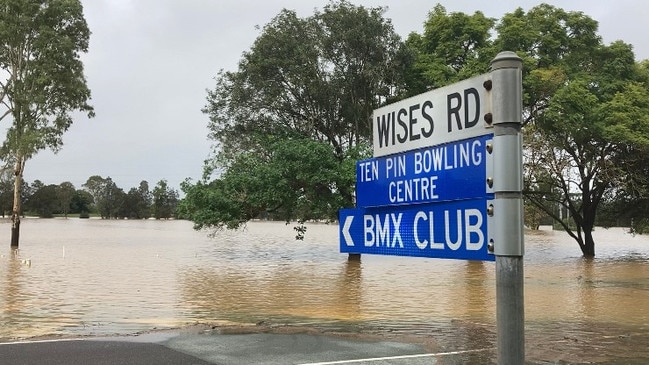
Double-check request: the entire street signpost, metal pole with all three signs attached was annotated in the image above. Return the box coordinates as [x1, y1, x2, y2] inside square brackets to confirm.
[339, 52, 525, 365]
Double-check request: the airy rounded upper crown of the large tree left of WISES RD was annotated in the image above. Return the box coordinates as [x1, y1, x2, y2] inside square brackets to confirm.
[204, 2, 405, 155]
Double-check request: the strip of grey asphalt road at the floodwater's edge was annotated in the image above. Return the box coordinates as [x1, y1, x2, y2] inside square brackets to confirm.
[0, 333, 492, 365]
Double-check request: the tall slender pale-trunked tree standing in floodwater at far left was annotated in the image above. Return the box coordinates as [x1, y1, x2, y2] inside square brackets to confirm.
[0, 0, 93, 247]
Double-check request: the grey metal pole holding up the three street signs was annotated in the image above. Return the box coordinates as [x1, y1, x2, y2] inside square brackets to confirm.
[491, 52, 525, 365]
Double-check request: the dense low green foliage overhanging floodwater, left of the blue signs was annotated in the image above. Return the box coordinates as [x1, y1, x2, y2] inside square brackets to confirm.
[179, 138, 363, 233]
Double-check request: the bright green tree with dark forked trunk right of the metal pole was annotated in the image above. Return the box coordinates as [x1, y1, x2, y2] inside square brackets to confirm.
[496, 5, 649, 257]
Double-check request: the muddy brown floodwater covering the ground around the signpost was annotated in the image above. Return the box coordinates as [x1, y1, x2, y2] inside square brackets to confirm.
[0, 219, 649, 364]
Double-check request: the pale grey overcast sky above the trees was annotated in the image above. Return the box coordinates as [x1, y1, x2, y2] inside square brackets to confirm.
[25, 0, 649, 191]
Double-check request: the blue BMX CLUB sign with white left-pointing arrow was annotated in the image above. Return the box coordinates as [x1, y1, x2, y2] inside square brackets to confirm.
[338, 199, 495, 261]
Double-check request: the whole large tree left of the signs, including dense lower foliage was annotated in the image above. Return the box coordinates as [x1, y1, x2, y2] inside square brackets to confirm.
[189, 1, 410, 235]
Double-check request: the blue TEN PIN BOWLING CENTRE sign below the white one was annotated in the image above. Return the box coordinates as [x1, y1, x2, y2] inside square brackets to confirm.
[356, 134, 493, 207]
